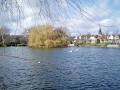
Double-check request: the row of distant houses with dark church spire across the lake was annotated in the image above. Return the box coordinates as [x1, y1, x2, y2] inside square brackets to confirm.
[71, 28, 120, 45]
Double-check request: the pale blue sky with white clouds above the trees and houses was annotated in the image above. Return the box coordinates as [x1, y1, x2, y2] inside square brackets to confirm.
[0, 0, 120, 35]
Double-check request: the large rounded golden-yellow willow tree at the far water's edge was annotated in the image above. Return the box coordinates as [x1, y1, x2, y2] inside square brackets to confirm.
[28, 25, 69, 48]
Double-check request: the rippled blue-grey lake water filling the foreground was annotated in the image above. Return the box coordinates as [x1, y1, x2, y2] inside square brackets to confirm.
[0, 47, 120, 90]
